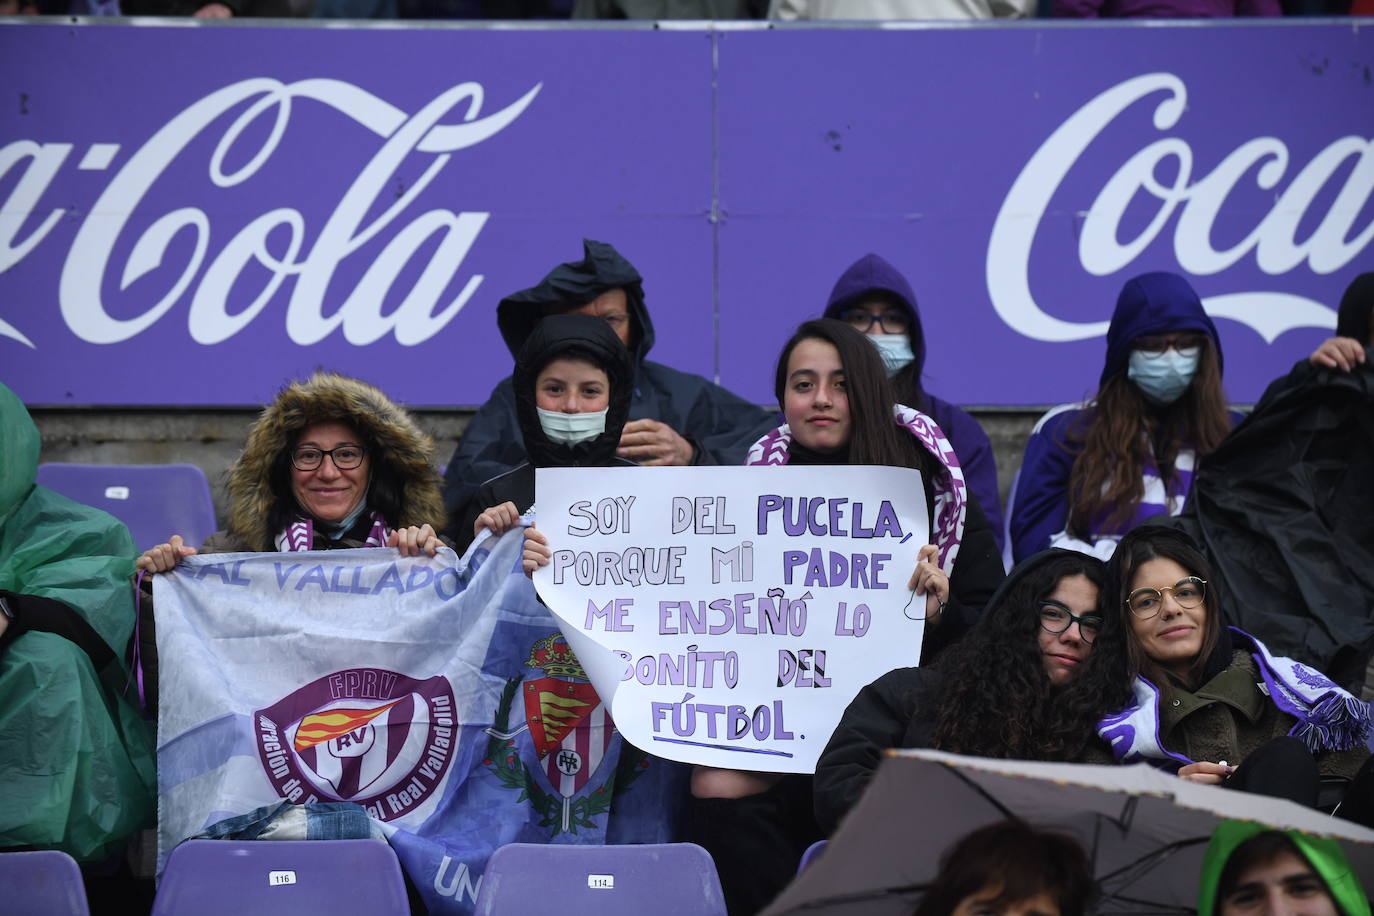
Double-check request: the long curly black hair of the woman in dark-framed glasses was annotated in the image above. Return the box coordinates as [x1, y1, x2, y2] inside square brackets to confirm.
[923, 549, 1129, 761]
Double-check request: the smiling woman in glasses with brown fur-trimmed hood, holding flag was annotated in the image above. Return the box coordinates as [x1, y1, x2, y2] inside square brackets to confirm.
[136, 372, 445, 705]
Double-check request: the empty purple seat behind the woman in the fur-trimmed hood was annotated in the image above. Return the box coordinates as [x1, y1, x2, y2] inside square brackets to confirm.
[38, 463, 214, 551]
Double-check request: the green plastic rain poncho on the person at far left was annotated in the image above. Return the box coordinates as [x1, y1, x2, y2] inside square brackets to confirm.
[0, 385, 157, 861]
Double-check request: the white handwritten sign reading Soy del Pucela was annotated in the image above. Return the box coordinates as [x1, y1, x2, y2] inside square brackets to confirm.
[534, 467, 929, 773]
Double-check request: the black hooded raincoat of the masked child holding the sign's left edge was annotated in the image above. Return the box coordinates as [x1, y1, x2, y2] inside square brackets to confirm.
[453, 314, 635, 551]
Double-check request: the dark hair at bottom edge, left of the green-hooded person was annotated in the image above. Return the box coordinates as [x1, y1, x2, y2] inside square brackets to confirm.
[915, 817, 1095, 916]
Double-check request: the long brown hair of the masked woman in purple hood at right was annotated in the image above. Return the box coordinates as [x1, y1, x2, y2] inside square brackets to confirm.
[1068, 335, 1231, 540]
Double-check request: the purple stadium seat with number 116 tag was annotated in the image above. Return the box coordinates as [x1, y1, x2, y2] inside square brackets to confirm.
[153, 839, 411, 916]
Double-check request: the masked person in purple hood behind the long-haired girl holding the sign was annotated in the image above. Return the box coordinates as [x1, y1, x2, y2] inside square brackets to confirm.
[824, 254, 1004, 549]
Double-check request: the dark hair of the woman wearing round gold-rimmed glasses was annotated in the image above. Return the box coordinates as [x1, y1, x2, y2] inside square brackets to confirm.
[1107, 525, 1221, 684]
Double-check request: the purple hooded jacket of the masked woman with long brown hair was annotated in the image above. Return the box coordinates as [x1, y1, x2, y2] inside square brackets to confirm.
[1007, 272, 1241, 562]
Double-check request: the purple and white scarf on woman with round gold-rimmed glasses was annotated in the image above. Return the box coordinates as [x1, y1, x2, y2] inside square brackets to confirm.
[1098, 626, 1370, 766]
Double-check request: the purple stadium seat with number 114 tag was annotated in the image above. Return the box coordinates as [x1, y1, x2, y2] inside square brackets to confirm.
[477, 843, 725, 916]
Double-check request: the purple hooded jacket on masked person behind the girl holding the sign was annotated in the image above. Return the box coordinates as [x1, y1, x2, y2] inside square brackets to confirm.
[824, 254, 1006, 551]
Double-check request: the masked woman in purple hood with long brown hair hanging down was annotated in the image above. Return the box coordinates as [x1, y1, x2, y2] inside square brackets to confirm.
[1007, 272, 1239, 562]
